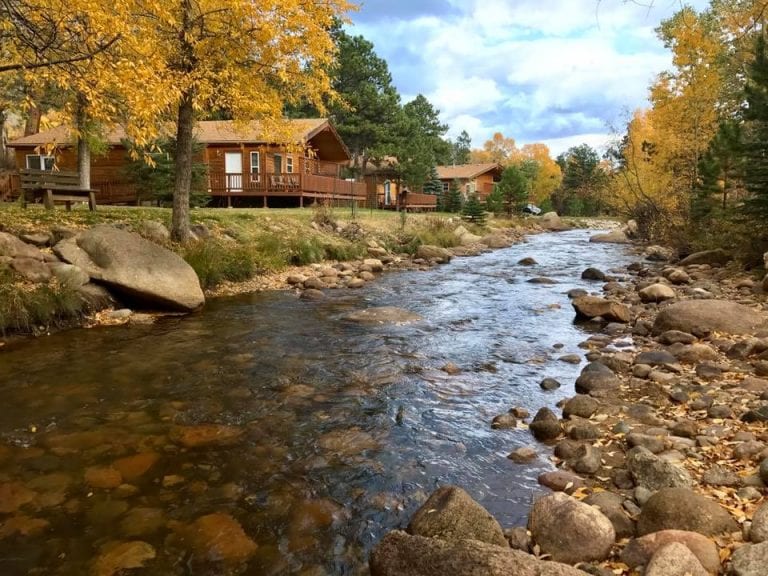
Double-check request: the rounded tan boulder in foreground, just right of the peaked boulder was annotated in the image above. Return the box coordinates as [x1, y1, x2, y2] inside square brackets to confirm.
[528, 492, 616, 564]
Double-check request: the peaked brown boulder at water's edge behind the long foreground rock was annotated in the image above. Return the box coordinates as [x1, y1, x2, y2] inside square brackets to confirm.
[408, 486, 507, 546]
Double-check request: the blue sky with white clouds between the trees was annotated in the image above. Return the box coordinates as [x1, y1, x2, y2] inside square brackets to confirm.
[348, 0, 709, 157]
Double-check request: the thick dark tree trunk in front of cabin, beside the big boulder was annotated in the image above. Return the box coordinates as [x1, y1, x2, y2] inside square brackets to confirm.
[171, 88, 194, 244]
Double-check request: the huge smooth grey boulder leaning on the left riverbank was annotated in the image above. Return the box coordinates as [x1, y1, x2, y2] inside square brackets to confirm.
[54, 225, 205, 312]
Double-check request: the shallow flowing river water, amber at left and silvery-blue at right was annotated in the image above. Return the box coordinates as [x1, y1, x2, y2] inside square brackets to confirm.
[0, 231, 627, 576]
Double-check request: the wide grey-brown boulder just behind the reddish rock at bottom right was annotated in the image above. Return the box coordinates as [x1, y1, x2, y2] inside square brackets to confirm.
[637, 488, 739, 536]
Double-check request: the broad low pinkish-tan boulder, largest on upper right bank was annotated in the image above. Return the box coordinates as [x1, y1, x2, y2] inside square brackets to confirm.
[653, 300, 766, 338]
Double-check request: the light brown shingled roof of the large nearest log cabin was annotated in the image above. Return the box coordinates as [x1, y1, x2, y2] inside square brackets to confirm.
[8, 118, 350, 160]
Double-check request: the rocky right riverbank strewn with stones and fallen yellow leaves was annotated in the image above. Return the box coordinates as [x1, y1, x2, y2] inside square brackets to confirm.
[370, 237, 768, 576]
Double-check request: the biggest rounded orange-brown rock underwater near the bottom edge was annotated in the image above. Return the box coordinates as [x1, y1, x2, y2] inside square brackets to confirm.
[176, 513, 258, 564]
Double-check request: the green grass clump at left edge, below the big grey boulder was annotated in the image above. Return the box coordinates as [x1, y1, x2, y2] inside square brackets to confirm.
[0, 269, 86, 334]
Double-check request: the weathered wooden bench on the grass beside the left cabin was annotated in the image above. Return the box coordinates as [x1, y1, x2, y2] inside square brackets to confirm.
[19, 169, 98, 211]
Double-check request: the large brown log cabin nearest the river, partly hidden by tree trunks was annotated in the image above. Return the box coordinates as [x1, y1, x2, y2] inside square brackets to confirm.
[8, 118, 366, 207]
